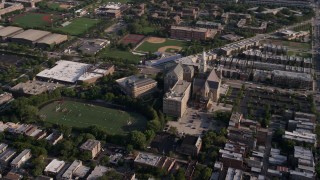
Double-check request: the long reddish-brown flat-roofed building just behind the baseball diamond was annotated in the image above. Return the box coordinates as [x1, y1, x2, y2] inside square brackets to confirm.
[170, 26, 210, 40]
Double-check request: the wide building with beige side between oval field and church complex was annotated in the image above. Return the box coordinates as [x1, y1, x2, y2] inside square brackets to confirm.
[116, 75, 158, 98]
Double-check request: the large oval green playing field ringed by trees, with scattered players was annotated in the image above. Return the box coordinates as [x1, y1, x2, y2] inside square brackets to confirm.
[40, 101, 147, 134]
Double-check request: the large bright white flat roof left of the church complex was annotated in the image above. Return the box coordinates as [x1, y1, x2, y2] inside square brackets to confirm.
[37, 60, 91, 83]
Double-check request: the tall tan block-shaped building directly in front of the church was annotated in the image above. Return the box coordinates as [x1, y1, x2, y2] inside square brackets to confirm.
[163, 80, 191, 117]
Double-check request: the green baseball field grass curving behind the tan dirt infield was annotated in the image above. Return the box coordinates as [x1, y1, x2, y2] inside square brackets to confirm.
[136, 39, 187, 52]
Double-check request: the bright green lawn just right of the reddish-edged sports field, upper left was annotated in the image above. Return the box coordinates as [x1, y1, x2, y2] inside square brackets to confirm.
[56, 18, 99, 36]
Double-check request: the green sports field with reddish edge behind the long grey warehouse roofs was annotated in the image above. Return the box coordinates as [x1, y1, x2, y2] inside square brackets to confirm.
[13, 13, 55, 28]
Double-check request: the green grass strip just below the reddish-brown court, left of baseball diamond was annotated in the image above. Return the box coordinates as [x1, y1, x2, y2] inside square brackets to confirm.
[99, 48, 141, 64]
